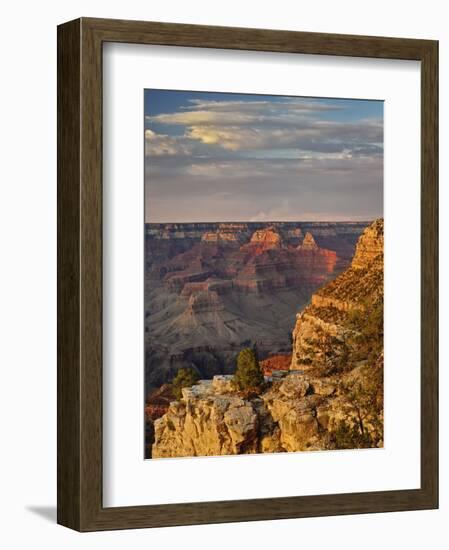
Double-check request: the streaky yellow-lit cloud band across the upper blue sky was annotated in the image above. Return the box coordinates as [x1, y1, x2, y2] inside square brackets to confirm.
[146, 99, 383, 155]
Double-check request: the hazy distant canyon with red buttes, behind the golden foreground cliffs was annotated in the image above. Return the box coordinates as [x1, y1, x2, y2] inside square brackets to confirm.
[145, 222, 367, 391]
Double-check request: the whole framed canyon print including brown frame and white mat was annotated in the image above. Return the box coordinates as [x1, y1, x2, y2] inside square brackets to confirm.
[58, 18, 438, 531]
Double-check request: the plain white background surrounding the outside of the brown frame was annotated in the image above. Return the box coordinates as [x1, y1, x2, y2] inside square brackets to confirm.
[0, 0, 449, 550]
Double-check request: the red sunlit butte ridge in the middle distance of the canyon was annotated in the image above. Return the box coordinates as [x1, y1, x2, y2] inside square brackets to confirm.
[154, 226, 338, 296]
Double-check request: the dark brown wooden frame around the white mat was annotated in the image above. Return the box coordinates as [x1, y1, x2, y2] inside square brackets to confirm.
[58, 18, 438, 531]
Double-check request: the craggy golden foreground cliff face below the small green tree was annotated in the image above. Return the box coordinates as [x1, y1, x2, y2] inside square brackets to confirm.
[152, 374, 325, 458]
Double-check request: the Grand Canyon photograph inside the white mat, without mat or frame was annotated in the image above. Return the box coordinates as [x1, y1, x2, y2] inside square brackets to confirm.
[144, 89, 384, 458]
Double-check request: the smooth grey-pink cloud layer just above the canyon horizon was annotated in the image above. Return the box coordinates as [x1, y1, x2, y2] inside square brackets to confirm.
[145, 153, 383, 222]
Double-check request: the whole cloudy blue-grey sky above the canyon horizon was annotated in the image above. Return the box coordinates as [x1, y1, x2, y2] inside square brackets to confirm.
[144, 90, 383, 223]
